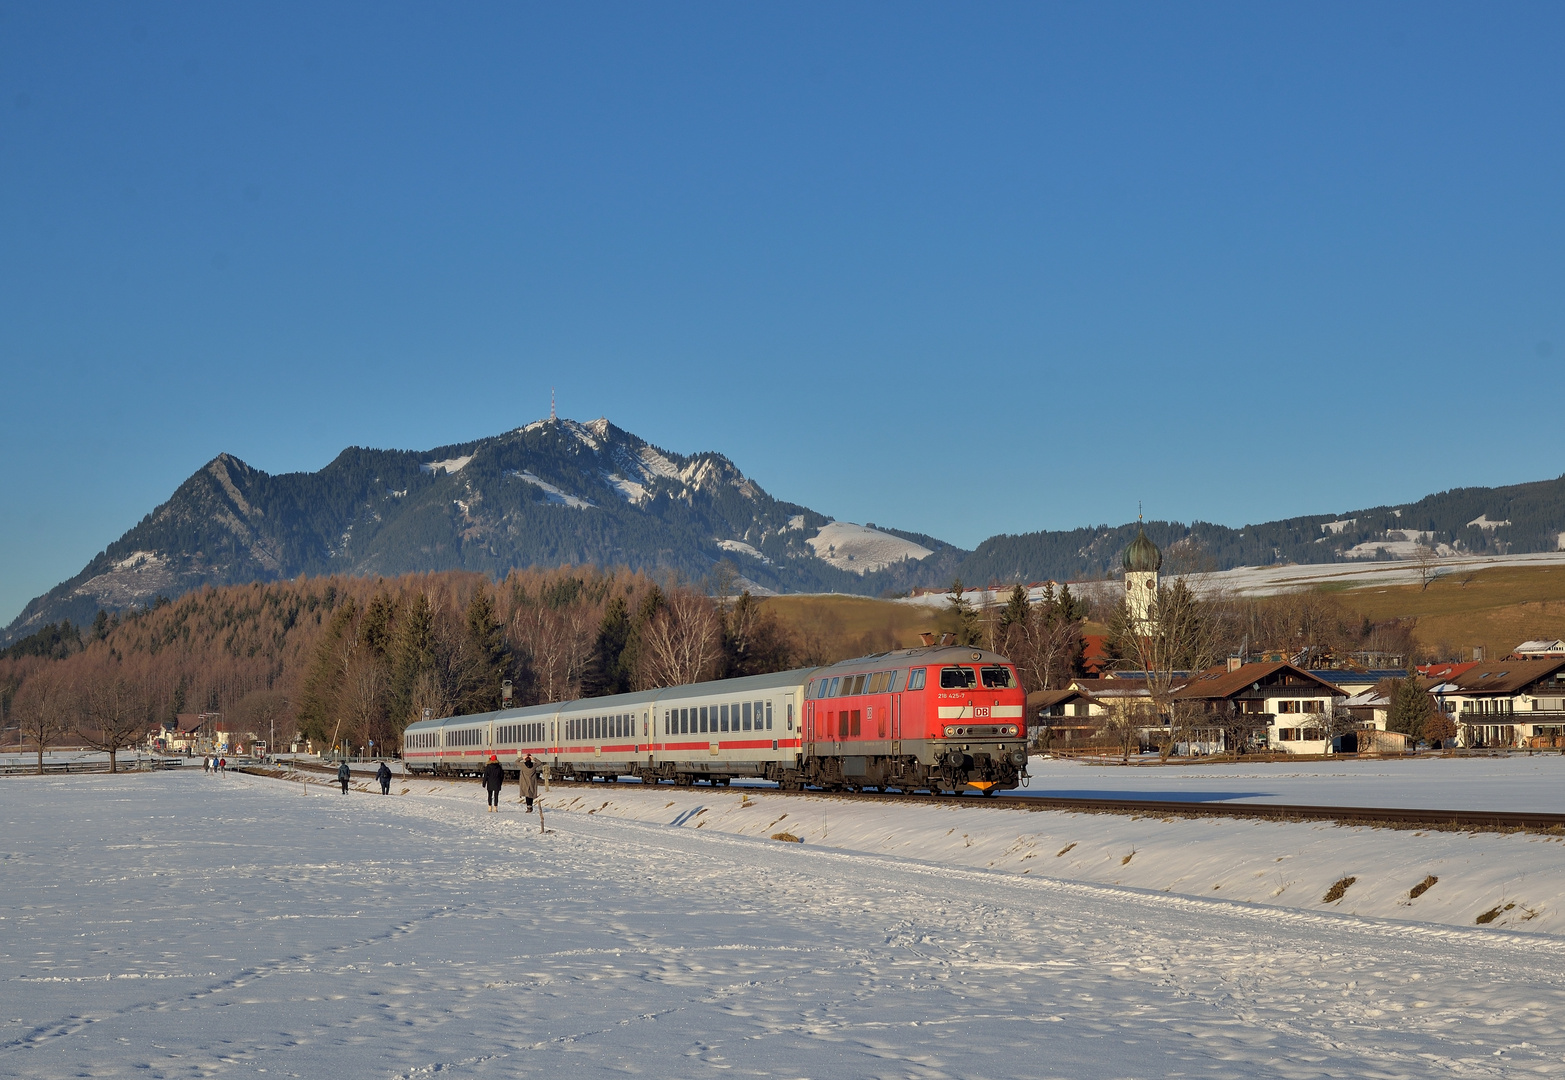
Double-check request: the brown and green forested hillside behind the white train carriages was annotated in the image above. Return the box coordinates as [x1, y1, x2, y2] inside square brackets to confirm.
[0, 568, 845, 747]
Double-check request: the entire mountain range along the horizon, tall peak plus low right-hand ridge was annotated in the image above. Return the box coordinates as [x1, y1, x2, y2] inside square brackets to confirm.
[9, 418, 1565, 643]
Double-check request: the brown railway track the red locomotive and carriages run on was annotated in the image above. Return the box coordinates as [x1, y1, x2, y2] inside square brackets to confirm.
[244, 762, 1565, 833]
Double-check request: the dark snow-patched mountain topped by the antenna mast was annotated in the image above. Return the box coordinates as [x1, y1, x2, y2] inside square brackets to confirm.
[3, 418, 956, 640]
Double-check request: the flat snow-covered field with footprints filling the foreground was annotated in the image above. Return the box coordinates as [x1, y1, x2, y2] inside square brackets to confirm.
[9, 775, 1565, 1077]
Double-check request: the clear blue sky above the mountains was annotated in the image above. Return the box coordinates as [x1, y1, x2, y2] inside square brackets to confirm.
[0, 3, 1565, 621]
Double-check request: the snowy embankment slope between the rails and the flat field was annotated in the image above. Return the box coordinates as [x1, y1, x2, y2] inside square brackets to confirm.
[237, 766, 1565, 934]
